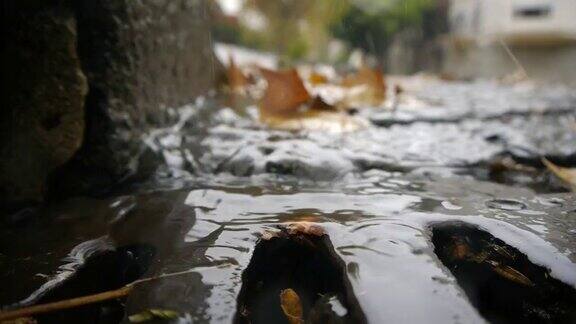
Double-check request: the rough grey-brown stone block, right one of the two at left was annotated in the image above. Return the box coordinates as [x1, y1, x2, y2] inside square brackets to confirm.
[53, 0, 218, 195]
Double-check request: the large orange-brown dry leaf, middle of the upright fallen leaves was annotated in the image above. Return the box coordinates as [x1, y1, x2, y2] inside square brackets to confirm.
[259, 68, 310, 115]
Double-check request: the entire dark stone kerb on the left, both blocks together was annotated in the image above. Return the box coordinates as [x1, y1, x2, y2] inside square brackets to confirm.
[0, 0, 219, 210]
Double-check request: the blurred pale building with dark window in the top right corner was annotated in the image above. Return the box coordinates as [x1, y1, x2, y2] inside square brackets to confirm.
[445, 0, 576, 84]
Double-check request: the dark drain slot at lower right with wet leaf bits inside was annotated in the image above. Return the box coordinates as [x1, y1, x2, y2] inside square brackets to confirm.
[432, 224, 576, 323]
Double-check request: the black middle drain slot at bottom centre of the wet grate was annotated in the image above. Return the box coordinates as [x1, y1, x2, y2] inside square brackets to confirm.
[234, 233, 367, 324]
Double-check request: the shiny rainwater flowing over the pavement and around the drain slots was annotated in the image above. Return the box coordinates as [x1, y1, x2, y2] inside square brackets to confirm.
[0, 80, 576, 323]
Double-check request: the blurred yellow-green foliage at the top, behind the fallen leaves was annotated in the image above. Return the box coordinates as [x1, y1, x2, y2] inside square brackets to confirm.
[214, 0, 434, 62]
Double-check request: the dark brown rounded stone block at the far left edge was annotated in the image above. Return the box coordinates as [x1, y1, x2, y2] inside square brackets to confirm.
[0, 1, 88, 213]
